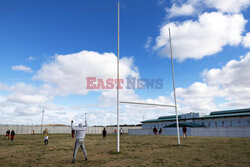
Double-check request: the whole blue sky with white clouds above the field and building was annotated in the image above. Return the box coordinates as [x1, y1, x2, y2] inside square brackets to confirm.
[0, 0, 250, 125]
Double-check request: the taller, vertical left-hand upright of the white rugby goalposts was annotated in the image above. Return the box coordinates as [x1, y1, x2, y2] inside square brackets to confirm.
[116, 0, 120, 152]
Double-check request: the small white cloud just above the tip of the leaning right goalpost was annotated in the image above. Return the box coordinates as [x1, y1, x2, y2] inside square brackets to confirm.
[165, 3, 197, 17]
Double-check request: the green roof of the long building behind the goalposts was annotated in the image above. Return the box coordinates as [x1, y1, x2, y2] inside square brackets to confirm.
[142, 108, 250, 123]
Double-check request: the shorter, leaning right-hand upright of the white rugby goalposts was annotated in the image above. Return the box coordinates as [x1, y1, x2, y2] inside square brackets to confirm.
[168, 28, 181, 145]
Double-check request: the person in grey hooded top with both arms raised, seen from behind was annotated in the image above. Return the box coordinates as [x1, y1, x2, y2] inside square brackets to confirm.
[71, 120, 88, 163]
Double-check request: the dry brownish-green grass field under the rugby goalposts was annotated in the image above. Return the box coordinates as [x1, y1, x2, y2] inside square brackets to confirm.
[0, 134, 250, 167]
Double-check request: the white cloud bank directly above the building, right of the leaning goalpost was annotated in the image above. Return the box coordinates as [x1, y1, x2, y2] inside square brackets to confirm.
[166, 52, 250, 114]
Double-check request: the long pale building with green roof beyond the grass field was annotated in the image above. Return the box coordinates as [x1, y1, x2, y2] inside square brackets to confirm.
[129, 108, 250, 137]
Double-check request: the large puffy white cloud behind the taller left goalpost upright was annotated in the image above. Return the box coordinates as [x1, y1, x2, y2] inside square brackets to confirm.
[33, 51, 139, 95]
